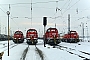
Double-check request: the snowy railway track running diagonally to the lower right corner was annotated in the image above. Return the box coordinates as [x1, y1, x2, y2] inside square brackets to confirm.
[54, 45, 90, 60]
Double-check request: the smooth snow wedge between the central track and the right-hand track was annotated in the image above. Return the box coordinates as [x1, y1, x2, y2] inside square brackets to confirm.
[37, 45, 80, 60]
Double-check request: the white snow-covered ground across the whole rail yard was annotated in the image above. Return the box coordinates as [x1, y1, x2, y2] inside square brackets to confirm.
[0, 40, 90, 60]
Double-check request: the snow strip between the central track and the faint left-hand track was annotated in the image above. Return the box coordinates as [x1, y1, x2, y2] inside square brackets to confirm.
[2, 44, 27, 60]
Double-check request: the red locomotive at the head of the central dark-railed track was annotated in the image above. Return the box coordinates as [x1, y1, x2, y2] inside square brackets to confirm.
[26, 29, 38, 44]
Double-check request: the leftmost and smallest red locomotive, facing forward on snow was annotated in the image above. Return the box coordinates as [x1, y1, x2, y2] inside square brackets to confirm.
[13, 31, 24, 43]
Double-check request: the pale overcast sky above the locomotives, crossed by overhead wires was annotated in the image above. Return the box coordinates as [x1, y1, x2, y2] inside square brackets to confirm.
[0, 0, 90, 36]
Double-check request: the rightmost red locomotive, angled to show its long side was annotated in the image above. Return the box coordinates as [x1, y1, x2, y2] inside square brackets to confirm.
[62, 31, 79, 43]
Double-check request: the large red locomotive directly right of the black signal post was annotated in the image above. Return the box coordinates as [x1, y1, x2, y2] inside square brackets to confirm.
[44, 28, 61, 44]
